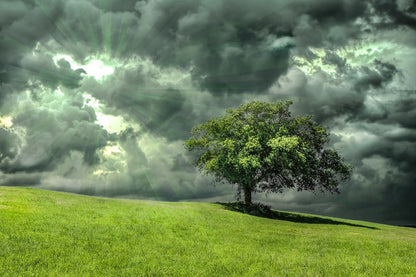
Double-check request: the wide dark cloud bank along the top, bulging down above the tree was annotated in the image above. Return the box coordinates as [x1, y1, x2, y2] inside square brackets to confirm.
[33, 0, 366, 94]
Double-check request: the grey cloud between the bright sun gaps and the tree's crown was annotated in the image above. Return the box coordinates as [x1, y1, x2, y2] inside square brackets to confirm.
[81, 61, 196, 140]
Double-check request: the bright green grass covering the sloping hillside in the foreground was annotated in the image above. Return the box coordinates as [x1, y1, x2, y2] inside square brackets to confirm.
[0, 187, 416, 276]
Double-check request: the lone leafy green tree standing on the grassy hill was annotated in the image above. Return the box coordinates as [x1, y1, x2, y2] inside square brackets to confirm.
[185, 101, 352, 204]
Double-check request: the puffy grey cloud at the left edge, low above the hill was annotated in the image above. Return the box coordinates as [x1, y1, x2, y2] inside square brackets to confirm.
[1, 90, 107, 173]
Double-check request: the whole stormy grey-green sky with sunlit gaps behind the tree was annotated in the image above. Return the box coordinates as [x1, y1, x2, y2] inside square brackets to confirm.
[0, 0, 416, 225]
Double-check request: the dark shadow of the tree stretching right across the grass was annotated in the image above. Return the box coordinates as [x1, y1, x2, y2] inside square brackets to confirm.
[217, 202, 379, 230]
